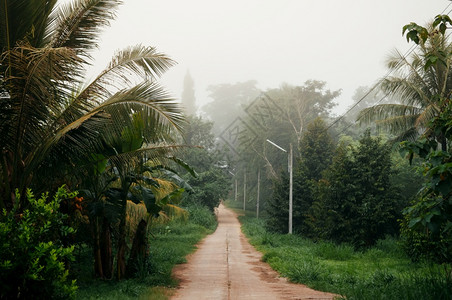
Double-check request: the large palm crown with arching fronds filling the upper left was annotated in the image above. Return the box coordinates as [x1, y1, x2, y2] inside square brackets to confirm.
[0, 0, 183, 208]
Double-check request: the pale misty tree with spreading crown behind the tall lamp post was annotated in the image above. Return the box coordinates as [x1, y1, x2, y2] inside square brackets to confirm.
[236, 80, 340, 218]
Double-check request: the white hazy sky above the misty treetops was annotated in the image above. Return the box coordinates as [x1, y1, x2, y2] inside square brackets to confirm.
[86, 0, 452, 113]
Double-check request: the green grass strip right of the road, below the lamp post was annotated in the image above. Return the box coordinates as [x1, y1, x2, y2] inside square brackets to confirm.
[239, 216, 452, 300]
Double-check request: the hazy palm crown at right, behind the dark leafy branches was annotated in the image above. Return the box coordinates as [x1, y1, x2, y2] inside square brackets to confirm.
[358, 23, 452, 140]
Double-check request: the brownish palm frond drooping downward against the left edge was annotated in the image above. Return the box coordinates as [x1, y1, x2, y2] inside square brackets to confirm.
[1, 44, 82, 153]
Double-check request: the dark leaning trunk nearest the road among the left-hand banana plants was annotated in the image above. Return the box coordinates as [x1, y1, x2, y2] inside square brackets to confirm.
[127, 219, 148, 277]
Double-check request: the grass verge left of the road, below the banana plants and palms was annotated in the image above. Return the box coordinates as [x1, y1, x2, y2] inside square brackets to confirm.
[76, 207, 216, 300]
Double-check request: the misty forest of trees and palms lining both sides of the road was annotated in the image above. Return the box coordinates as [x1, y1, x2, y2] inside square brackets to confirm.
[0, 0, 452, 299]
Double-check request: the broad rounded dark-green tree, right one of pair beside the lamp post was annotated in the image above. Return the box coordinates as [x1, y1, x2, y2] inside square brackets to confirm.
[312, 131, 403, 247]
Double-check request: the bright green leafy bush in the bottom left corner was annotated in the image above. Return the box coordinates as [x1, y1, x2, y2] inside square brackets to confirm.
[0, 187, 77, 299]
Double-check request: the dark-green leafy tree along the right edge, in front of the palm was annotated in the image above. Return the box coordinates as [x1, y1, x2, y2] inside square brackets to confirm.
[402, 15, 452, 263]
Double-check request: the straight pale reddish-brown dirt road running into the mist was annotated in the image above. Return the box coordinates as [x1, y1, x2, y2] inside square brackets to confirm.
[172, 205, 334, 300]
